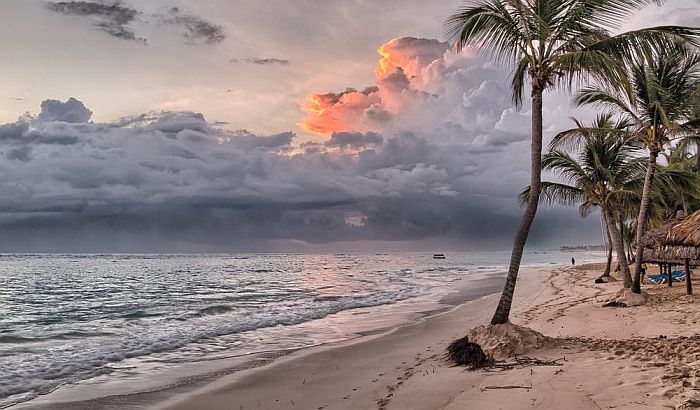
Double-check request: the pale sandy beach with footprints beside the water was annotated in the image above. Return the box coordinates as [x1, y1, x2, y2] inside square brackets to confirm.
[154, 264, 700, 410]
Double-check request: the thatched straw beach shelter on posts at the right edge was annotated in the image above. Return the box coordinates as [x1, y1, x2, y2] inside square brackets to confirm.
[642, 211, 700, 295]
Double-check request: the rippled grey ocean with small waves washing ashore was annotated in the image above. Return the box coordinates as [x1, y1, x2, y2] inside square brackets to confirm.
[0, 250, 604, 408]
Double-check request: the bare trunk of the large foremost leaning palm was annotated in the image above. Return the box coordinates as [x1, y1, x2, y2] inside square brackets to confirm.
[491, 84, 544, 325]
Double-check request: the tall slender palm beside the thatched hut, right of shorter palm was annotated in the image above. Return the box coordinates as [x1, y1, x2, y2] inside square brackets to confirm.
[575, 50, 700, 293]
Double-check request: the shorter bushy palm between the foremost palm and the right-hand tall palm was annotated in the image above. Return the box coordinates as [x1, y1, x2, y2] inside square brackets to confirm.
[520, 113, 644, 287]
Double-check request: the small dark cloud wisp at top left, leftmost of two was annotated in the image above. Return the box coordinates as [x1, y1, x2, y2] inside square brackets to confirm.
[46, 1, 145, 42]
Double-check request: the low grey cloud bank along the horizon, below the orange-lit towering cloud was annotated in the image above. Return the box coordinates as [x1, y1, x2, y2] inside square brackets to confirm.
[0, 91, 600, 251]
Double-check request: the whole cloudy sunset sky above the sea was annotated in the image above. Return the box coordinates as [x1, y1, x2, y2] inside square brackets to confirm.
[0, 0, 700, 252]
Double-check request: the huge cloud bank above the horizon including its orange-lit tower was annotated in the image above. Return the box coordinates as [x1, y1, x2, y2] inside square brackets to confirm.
[0, 34, 599, 252]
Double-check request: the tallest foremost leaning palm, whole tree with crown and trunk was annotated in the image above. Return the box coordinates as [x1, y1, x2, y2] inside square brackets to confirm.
[445, 0, 699, 325]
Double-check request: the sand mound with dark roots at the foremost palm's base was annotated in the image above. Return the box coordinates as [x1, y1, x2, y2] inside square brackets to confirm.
[467, 322, 552, 359]
